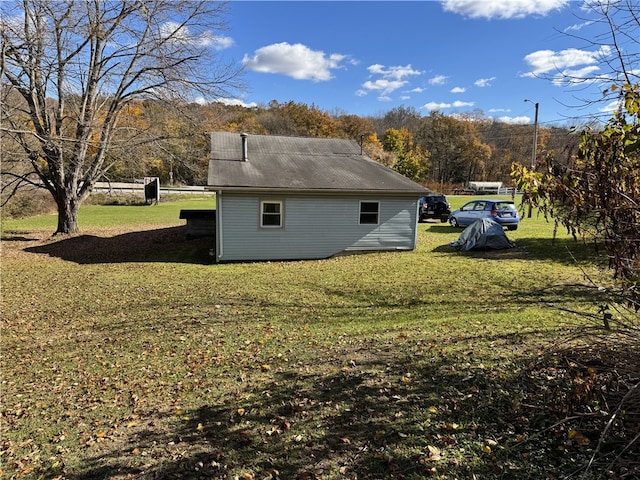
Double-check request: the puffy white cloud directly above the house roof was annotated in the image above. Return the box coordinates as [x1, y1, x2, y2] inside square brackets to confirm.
[242, 42, 347, 82]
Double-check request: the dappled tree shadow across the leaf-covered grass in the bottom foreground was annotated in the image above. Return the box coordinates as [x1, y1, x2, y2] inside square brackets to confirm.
[66, 342, 638, 480]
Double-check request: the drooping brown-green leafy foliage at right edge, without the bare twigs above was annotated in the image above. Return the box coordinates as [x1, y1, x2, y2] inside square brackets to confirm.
[512, 84, 640, 310]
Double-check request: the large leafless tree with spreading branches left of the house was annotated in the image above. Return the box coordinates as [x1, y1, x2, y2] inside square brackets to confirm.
[0, 0, 242, 233]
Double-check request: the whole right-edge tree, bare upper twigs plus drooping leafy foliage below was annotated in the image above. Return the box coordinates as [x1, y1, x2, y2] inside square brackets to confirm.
[512, 0, 640, 309]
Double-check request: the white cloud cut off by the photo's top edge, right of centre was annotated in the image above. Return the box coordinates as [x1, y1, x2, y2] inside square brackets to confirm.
[440, 0, 569, 20]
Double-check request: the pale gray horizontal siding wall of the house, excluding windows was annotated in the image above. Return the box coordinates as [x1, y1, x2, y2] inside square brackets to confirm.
[217, 192, 418, 261]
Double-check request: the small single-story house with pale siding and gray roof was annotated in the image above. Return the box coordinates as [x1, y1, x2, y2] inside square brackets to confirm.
[207, 132, 427, 262]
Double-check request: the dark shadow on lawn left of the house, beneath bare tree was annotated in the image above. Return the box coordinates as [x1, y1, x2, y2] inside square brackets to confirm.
[24, 226, 215, 264]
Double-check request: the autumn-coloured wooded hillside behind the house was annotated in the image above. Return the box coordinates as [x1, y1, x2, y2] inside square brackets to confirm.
[2, 96, 578, 190]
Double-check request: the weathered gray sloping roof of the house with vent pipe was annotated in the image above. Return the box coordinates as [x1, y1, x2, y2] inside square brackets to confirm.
[208, 132, 426, 194]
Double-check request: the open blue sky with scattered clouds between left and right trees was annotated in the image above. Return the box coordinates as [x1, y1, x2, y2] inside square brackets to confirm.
[212, 0, 628, 126]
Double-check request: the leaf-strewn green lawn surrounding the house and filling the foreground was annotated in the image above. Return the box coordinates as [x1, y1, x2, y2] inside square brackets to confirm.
[0, 198, 640, 480]
